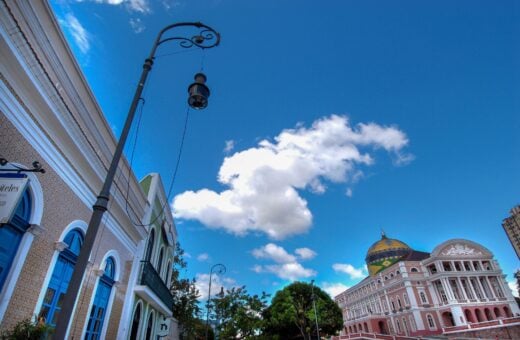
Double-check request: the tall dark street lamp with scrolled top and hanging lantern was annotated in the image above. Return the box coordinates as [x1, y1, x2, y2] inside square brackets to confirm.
[54, 22, 220, 339]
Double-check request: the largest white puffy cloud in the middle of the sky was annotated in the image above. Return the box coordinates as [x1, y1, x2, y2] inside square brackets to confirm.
[172, 115, 409, 239]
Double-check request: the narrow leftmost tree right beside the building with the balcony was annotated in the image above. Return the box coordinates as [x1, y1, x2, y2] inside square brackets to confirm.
[170, 243, 204, 339]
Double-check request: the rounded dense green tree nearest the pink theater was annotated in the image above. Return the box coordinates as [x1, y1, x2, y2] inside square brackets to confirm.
[264, 282, 343, 340]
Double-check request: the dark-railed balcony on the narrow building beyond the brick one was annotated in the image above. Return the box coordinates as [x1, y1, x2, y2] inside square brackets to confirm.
[135, 261, 173, 315]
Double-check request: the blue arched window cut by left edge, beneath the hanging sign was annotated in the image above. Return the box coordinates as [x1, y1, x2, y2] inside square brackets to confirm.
[0, 190, 31, 290]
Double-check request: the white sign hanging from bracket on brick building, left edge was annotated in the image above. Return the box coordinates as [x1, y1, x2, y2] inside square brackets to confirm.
[0, 174, 29, 223]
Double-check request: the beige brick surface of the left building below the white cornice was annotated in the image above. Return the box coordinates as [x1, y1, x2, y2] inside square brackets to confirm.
[0, 109, 138, 337]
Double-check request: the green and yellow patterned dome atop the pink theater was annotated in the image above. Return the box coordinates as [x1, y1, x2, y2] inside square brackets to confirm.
[365, 232, 412, 276]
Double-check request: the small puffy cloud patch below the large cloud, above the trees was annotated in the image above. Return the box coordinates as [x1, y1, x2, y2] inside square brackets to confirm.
[251, 243, 316, 281]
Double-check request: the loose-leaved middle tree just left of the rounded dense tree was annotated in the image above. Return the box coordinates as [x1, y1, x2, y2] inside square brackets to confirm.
[211, 286, 269, 339]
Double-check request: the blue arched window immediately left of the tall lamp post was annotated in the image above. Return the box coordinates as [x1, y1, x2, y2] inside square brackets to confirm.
[40, 229, 83, 327]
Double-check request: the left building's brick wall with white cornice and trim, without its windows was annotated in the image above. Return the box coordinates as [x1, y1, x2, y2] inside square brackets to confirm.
[0, 0, 152, 339]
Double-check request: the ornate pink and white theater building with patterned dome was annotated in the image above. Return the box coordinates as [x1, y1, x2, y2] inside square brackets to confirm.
[335, 234, 520, 338]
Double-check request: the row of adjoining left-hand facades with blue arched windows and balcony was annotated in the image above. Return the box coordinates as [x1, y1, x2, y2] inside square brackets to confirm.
[0, 0, 177, 339]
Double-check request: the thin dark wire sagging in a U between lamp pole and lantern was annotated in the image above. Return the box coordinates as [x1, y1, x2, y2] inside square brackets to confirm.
[125, 98, 190, 227]
